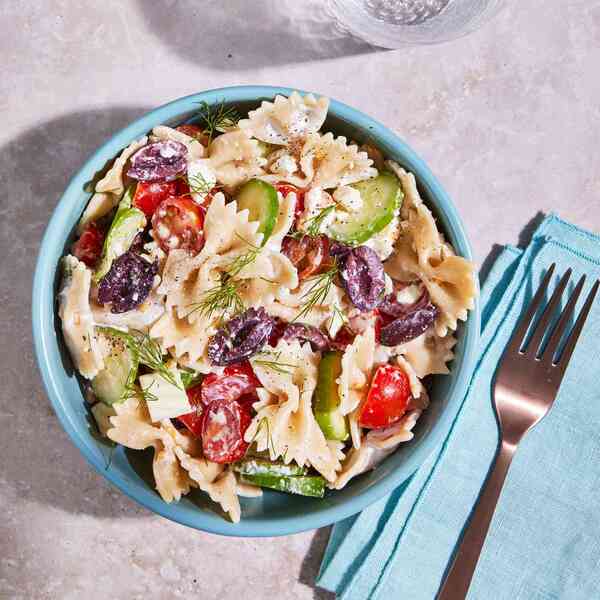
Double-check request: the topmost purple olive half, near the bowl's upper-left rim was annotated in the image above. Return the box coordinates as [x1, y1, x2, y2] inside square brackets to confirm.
[127, 140, 187, 181]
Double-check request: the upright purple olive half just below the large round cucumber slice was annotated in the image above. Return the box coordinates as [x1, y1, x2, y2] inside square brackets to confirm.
[329, 243, 385, 311]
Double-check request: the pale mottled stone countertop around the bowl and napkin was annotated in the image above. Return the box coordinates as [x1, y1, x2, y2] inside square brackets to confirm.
[0, 0, 600, 600]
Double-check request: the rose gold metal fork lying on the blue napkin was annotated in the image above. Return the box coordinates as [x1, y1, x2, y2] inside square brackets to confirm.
[437, 264, 600, 600]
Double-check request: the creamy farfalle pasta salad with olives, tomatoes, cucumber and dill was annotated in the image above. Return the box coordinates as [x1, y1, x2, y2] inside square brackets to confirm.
[58, 92, 476, 522]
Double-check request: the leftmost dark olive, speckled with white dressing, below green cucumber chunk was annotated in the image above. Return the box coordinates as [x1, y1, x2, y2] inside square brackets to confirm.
[98, 250, 158, 313]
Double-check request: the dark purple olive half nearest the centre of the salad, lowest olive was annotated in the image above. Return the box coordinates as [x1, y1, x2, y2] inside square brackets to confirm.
[208, 308, 275, 366]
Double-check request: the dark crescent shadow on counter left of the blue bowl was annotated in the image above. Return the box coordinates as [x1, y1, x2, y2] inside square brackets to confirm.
[0, 107, 149, 518]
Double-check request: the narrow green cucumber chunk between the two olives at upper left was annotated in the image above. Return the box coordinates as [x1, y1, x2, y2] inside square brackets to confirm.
[94, 185, 146, 283]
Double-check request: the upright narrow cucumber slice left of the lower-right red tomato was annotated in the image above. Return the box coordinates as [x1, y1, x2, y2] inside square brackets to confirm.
[313, 351, 349, 441]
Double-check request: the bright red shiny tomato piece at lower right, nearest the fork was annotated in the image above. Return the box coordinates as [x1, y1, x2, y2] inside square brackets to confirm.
[358, 365, 412, 429]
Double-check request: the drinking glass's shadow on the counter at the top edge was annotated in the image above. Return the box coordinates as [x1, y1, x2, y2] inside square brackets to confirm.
[132, 0, 377, 71]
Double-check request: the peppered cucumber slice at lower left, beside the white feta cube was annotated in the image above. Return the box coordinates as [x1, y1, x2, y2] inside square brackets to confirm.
[92, 327, 138, 404]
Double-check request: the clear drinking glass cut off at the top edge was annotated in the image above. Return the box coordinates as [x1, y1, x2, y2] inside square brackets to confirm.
[328, 0, 504, 48]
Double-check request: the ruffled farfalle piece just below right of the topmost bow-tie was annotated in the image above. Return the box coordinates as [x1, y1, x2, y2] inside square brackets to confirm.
[300, 133, 377, 190]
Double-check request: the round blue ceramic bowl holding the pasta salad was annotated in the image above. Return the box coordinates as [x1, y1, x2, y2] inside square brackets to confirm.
[32, 86, 479, 536]
